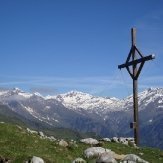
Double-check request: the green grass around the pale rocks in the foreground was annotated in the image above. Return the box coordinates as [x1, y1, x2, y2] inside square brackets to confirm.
[0, 123, 163, 163]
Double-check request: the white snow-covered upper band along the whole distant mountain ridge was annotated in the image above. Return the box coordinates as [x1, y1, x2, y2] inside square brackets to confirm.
[0, 88, 163, 114]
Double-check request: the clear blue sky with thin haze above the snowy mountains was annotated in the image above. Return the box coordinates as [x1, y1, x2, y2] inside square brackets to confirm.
[0, 0, 163, 98]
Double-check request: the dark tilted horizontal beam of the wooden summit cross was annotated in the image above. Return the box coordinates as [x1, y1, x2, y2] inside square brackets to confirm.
[118, 54, 155, 69]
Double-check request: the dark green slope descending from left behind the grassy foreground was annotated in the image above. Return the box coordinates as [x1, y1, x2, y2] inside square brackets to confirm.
[0, 104, 95, 139]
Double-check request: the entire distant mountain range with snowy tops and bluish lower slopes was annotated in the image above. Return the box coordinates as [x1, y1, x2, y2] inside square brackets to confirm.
[0, 88, 163, 149]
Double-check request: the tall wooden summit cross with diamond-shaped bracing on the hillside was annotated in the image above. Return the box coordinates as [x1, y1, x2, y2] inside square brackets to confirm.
[118, 28, 155, 145]
